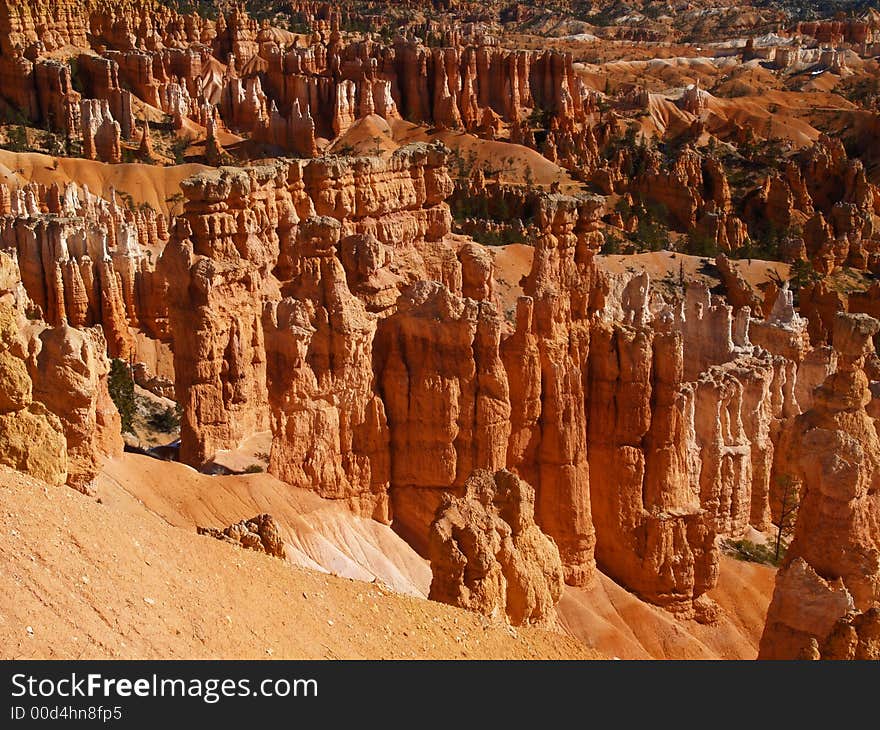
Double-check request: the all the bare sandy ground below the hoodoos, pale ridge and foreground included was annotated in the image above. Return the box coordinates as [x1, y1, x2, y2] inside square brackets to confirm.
[0, 454, 774, 659]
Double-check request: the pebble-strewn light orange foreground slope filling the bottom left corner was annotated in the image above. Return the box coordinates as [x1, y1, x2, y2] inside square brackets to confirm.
[0, 467, 596, 659]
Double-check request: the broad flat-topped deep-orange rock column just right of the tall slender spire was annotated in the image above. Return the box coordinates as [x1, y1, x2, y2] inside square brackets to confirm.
[589, 318, 719, 612]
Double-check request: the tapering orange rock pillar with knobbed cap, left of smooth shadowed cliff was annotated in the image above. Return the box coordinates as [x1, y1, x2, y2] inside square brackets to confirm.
[262, 213, 391, 522]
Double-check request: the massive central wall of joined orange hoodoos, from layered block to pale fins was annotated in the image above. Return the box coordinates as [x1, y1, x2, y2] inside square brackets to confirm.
[141, 154, 844, 620]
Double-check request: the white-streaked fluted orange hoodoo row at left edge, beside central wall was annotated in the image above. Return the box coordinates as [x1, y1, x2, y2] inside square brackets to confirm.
[0, 178, 168, 359]
